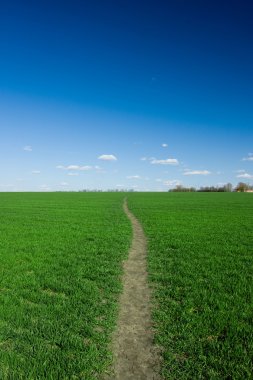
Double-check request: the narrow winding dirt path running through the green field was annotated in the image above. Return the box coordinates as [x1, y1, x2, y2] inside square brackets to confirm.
[108, 200, 160, 380]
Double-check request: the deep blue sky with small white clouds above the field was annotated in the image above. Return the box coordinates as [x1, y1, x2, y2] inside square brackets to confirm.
[0, 0, 253, 191]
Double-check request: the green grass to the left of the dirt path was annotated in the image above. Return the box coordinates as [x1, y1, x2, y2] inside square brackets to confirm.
[0, 193, 131, 380]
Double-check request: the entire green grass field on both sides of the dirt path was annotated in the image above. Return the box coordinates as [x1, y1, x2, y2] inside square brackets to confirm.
[0, 193, 253, 380]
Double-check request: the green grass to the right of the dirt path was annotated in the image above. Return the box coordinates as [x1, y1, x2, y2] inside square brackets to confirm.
[128, 193, 253, 380]
